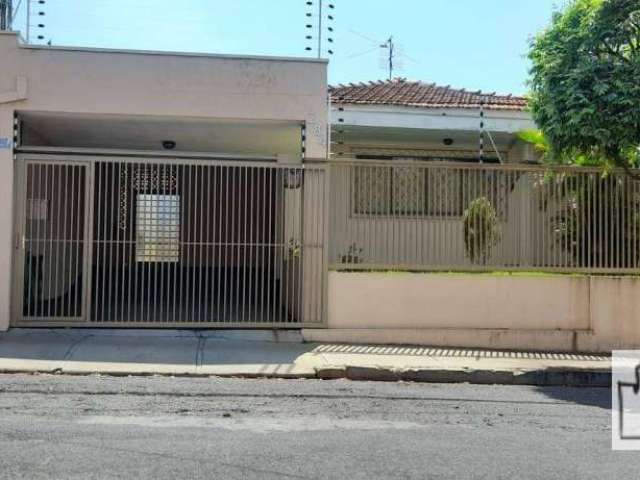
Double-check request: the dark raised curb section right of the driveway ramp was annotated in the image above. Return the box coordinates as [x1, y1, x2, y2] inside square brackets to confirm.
[316, 366, 611, 387]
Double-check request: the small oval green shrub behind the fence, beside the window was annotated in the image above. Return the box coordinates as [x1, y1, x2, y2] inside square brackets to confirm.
[462, 197, 501, 265]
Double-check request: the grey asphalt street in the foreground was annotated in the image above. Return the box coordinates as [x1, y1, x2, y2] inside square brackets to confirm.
[0, 375, 640, 480]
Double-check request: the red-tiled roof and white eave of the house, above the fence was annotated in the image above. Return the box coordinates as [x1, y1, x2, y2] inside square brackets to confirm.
[329, 79, 535, 163]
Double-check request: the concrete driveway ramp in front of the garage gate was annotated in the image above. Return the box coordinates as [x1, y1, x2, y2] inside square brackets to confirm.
[0, 329, 316, 377]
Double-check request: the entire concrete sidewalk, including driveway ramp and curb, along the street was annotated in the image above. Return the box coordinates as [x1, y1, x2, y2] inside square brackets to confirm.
[0, 329, 611, 386]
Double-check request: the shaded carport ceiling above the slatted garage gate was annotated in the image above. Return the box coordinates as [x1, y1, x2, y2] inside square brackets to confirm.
[19, 112, 302, 157]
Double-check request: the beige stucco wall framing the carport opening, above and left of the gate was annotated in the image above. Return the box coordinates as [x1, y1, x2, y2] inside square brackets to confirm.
[0, 32, 328, 331]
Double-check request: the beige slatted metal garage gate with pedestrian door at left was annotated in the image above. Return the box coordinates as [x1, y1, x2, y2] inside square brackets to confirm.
[13, 155, 328, 327]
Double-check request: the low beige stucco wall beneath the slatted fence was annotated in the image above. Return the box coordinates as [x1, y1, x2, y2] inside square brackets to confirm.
[304, 271, 640, 352]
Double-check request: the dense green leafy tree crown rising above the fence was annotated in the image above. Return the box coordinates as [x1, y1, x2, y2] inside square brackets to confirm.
[529, 0, 640, 171]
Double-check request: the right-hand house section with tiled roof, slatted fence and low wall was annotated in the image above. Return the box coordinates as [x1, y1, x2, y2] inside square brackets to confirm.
[320, 79, 640, 351]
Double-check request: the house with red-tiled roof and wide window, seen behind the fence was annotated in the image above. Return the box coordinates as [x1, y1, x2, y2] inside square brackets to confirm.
[329, 79, 551, 270]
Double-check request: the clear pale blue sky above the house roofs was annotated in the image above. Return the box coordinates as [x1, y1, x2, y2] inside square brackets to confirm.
[8, 0, 564, 94]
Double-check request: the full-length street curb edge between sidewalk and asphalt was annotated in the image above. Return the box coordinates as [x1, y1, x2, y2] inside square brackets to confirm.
[0, 365, 611, 387]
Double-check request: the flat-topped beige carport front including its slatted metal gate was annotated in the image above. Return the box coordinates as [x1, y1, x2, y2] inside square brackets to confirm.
[0, 32, 329, 329]
